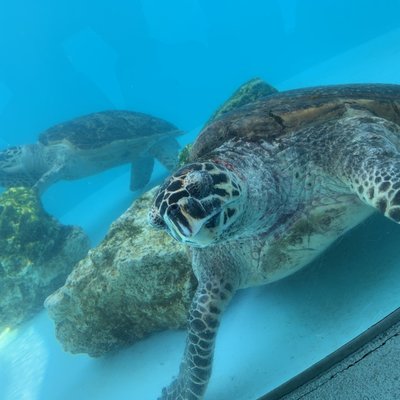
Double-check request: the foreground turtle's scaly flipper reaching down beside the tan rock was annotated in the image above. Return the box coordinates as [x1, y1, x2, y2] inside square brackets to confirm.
[159, 248, 238, 400]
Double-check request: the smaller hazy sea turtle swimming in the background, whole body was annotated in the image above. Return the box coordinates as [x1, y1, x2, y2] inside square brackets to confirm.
[0, 110, 182, 193]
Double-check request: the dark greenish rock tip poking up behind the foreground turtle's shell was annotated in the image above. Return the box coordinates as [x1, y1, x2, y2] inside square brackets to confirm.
[206, 78, 277, 126]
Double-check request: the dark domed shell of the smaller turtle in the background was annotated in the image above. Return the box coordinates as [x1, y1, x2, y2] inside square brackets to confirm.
[39, 110, 182, 149]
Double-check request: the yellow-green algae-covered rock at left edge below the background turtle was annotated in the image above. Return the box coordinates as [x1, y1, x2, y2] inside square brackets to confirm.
[0, 188, 89, 331]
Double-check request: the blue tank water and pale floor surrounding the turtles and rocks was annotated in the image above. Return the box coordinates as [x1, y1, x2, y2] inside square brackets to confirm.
[0, 0, 400, 400]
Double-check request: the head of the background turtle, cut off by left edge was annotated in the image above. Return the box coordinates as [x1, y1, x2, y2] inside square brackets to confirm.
[0, 145, 45, 187]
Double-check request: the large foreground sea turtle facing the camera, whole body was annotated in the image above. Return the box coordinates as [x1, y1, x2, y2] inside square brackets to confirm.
[149, 84, 400, 400]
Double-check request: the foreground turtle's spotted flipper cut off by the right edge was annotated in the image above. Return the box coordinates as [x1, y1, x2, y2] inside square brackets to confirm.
[324, 116, 400, 223]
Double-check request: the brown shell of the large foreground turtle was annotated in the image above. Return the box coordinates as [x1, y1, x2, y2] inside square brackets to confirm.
[190, 84, 400, 161]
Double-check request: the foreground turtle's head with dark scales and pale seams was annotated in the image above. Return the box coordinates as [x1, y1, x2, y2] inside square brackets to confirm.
[149, 162, 246, 247]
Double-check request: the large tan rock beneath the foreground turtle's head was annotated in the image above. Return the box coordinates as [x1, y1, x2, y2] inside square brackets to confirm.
[45, 190, 196, 357]
